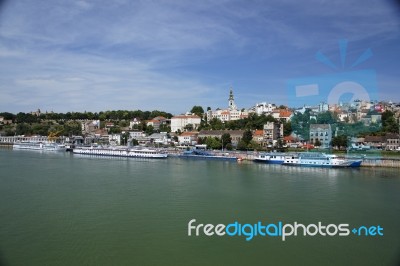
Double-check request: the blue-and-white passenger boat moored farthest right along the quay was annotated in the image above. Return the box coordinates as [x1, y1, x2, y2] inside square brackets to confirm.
[283, 152, 362, 168]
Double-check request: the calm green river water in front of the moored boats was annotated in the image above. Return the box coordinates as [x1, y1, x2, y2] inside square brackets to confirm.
[0, 149, 400, 265]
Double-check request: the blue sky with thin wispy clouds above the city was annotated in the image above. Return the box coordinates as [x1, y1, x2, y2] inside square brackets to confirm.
[0, 0, 400, 114]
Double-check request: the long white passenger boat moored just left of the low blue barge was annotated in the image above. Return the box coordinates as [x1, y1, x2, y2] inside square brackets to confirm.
[72, 146, 168, 159]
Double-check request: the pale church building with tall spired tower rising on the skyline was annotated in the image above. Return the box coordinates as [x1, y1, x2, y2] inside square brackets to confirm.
[207, 90, 249, 122]
